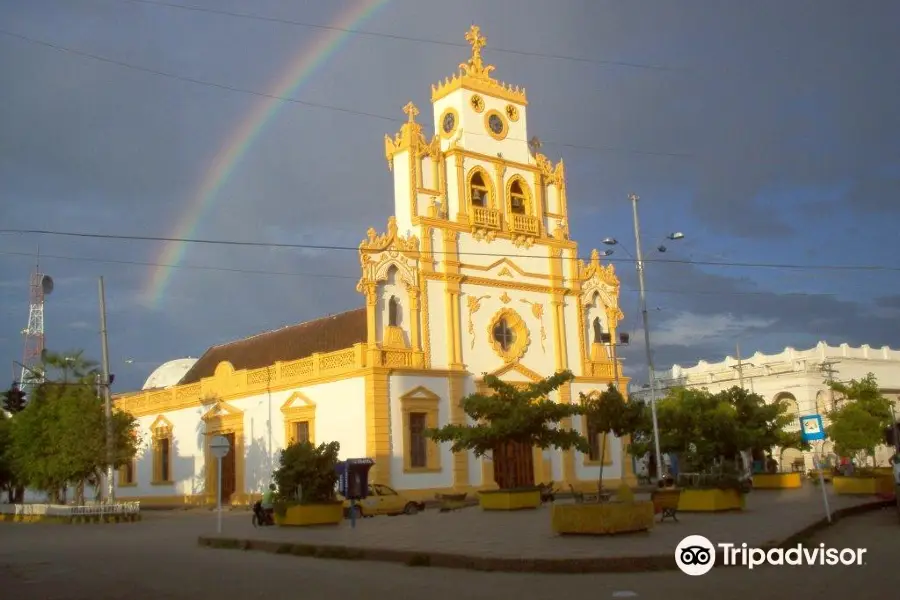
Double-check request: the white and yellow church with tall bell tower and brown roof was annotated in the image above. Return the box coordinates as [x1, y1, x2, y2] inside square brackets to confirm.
[115, 26, 634, 504]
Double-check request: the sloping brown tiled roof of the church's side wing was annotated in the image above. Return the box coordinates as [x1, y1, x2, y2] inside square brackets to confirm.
[179, 308, 367, 385]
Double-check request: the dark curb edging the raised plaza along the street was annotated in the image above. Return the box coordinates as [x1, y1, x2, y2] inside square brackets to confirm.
[197, 500, 893, 574]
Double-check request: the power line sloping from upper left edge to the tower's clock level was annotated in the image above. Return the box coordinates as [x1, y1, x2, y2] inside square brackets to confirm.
[0, 29, 693, 158]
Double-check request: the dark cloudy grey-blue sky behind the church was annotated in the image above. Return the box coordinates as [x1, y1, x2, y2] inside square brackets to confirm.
[0, 0, 900, 389]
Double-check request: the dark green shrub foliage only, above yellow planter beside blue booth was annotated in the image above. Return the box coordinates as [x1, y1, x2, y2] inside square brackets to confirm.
[273, 442, 341, 504]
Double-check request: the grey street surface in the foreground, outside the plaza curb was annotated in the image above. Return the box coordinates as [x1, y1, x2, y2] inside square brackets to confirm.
[0, 496, 900, 600]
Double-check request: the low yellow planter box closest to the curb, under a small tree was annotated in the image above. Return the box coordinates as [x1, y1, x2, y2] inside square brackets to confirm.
[551, 502, 653, 535]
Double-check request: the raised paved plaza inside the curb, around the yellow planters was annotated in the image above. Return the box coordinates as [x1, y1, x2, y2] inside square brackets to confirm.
[204, 485, 873, 559]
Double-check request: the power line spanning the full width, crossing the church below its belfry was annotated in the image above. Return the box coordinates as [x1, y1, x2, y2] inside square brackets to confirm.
[0, 229, 900, 272]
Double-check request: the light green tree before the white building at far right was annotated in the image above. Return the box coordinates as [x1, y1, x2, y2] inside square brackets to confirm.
[826, 373, 893, 458]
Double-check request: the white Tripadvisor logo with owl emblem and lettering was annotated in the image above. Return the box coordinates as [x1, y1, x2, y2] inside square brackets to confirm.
[675, 535, 866, 576]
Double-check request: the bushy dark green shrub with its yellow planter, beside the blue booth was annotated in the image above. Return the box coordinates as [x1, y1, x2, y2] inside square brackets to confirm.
[273, 442, 343, 525]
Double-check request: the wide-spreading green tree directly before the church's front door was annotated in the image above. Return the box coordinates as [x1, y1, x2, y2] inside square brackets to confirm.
[427, 371, 590, 489]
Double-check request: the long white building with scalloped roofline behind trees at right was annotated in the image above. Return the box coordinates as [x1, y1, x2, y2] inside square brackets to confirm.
[631, 342, 900, 470]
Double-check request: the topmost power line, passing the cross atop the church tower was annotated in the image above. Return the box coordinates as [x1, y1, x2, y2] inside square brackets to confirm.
[109, 0, 687, 72]
